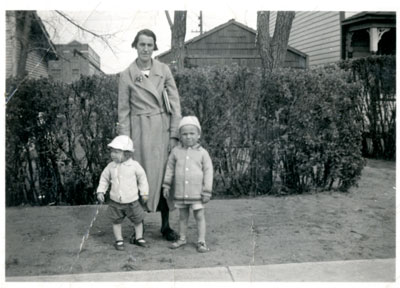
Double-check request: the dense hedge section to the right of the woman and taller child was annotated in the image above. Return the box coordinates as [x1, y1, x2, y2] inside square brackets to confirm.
[175, 67, 364, 196]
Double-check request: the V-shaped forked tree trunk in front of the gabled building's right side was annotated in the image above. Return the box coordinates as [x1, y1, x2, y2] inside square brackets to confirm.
[257, 11, 295, 71]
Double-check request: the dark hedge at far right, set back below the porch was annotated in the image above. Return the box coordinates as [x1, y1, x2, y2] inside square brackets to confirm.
[339, 55, 396, 160]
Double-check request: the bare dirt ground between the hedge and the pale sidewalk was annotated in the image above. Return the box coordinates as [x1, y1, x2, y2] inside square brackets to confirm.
[5, 160, 396, 281]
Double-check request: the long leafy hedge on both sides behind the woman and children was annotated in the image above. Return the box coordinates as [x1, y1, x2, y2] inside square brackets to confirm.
[6, 56, 390, 206]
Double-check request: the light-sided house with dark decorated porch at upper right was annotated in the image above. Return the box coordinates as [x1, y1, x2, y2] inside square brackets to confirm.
[270, 11, 396, 66]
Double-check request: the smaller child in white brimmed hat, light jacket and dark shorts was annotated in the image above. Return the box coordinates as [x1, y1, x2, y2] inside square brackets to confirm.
[96, 135, 149, 250]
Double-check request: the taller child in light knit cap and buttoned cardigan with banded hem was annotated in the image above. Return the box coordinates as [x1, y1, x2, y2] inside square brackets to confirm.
[163, 116, 213, 253]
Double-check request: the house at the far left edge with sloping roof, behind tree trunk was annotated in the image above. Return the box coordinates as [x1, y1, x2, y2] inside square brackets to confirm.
[5, 10, 57, 78]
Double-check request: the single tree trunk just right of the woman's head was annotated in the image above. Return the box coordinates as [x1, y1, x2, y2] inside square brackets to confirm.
[167, 11, 187, 71]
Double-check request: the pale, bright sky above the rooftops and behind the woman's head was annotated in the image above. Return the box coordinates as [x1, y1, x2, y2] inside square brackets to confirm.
[38, 9, 257, 74]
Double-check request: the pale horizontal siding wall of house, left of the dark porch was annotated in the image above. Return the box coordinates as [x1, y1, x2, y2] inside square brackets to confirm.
[270, 11, 341, 66]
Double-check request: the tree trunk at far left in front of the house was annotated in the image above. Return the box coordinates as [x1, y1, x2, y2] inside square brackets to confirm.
[17, 11, 32, 78]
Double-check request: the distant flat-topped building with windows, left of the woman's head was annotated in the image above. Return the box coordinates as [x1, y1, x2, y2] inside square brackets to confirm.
[49, 41, 104, 83]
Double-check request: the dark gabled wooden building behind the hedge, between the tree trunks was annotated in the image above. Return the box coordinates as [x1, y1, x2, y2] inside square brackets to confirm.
[155, 20, 308, 68]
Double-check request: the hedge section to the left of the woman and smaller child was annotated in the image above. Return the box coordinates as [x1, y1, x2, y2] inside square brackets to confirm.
[6, 76, 117, 206]
